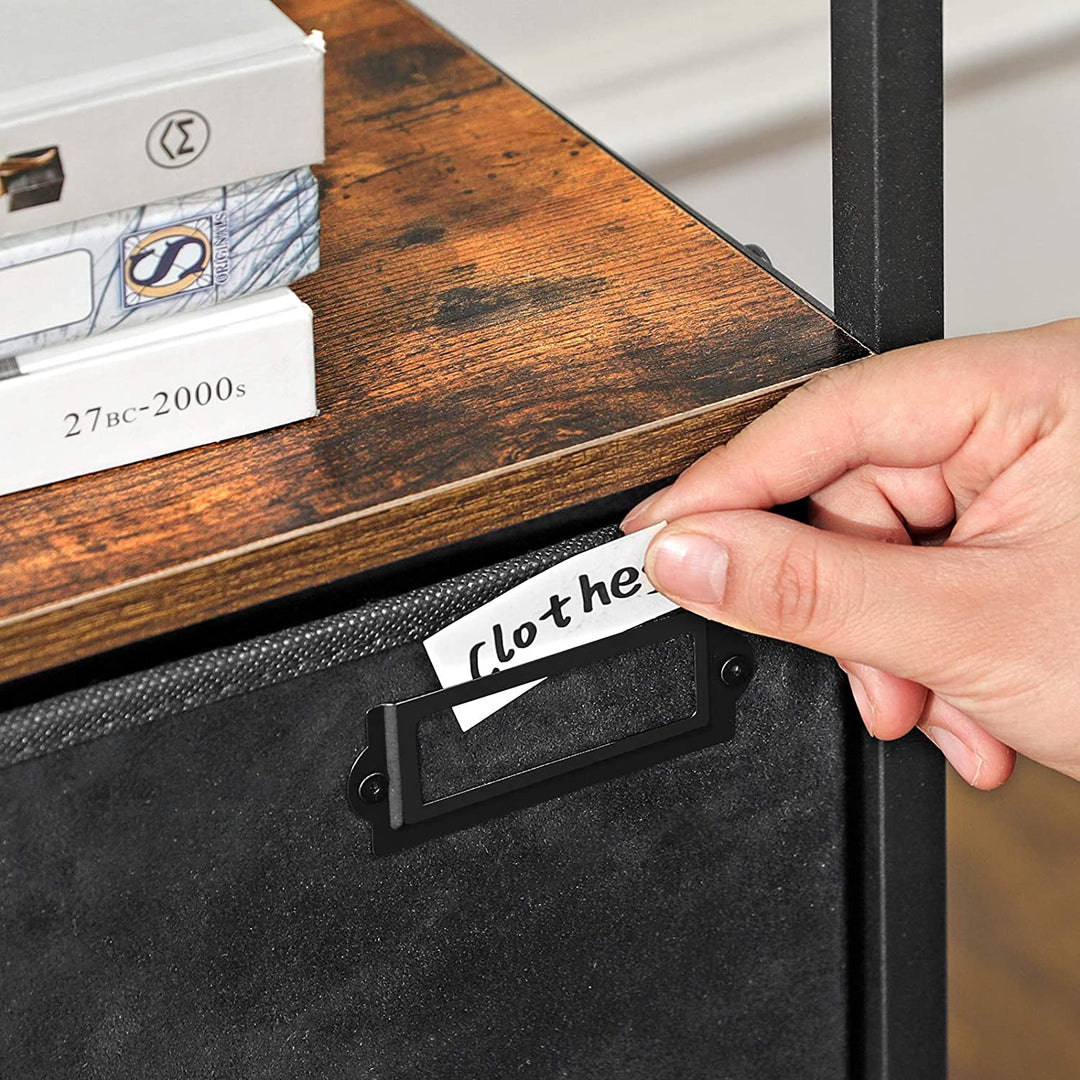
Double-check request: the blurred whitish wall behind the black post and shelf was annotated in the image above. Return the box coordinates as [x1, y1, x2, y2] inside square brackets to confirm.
[419, 0, 1080, 334]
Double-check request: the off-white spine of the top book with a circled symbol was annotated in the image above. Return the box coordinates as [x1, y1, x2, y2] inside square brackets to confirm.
[0, 38, 323, 237]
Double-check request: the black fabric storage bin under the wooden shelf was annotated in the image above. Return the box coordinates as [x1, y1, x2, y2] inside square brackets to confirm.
[0, 522, 849, 1080]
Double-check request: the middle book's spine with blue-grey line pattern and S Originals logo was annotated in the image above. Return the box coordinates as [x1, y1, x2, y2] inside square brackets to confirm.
[0, 168, 319, 356]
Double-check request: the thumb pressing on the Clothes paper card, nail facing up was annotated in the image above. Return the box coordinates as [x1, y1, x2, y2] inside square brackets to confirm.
[645, 510, 994, 687]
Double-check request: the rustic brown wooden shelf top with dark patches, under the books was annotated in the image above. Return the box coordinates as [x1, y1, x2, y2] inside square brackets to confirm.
[0, 0, 865, 679]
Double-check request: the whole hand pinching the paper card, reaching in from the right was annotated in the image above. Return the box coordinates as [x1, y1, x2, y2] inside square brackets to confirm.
[623, 320, 1080, 788]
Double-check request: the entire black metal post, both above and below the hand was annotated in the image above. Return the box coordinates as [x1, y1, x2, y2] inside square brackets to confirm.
[832, 0, 947, 1080]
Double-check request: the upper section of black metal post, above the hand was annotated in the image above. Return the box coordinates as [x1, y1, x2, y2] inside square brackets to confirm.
[832, 0, 944, 352]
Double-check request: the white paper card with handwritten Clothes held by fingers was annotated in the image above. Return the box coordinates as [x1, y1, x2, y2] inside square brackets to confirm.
[423, 522, 677, 731]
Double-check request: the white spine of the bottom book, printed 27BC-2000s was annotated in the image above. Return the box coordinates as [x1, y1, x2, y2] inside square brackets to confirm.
[0, 291, 315, 495]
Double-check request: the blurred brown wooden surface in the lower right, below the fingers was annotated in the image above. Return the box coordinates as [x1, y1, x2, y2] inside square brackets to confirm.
[948, 759, 1080, 1080]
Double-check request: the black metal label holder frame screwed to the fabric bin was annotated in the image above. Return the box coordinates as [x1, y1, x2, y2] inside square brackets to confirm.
[348, 611, 754, 855]
